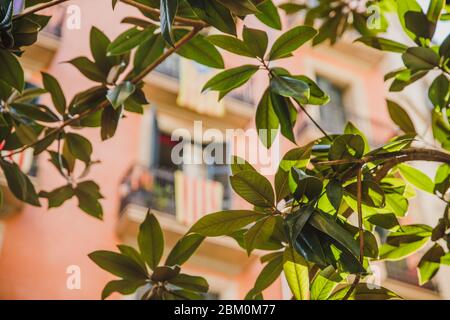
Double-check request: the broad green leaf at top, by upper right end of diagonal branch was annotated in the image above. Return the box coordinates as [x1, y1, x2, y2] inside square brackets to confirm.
[174, 29, 224, 69]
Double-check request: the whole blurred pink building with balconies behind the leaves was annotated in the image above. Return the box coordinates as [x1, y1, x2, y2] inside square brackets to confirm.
[0, 0, 450, 299]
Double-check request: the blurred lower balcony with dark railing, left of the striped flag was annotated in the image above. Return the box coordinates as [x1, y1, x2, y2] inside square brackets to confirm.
[117, 166, 261, 275]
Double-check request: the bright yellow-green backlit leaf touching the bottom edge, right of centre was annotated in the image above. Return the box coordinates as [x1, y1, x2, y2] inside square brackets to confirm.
[311, 266, 343, 300]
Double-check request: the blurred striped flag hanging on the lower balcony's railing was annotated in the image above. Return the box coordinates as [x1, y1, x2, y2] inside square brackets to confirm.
[175, 171, 223, 226]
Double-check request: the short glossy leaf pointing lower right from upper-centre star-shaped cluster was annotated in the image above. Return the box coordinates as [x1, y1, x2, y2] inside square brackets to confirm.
[270, 76, 310, 103]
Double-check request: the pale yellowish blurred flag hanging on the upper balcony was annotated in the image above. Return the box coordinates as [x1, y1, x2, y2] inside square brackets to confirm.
[177, 59, 225, 117]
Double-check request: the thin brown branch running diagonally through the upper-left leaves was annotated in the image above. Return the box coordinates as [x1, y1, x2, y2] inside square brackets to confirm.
[9, 27, 202, 156]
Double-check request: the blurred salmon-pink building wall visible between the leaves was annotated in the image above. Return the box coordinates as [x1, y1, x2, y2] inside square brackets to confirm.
[0, 0, 446, 299]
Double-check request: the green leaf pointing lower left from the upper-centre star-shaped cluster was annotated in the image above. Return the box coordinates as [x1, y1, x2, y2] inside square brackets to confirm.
[202, 64, 259, 93]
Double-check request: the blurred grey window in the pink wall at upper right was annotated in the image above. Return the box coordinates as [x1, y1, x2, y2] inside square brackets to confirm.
[317, 76, 347, 133]
